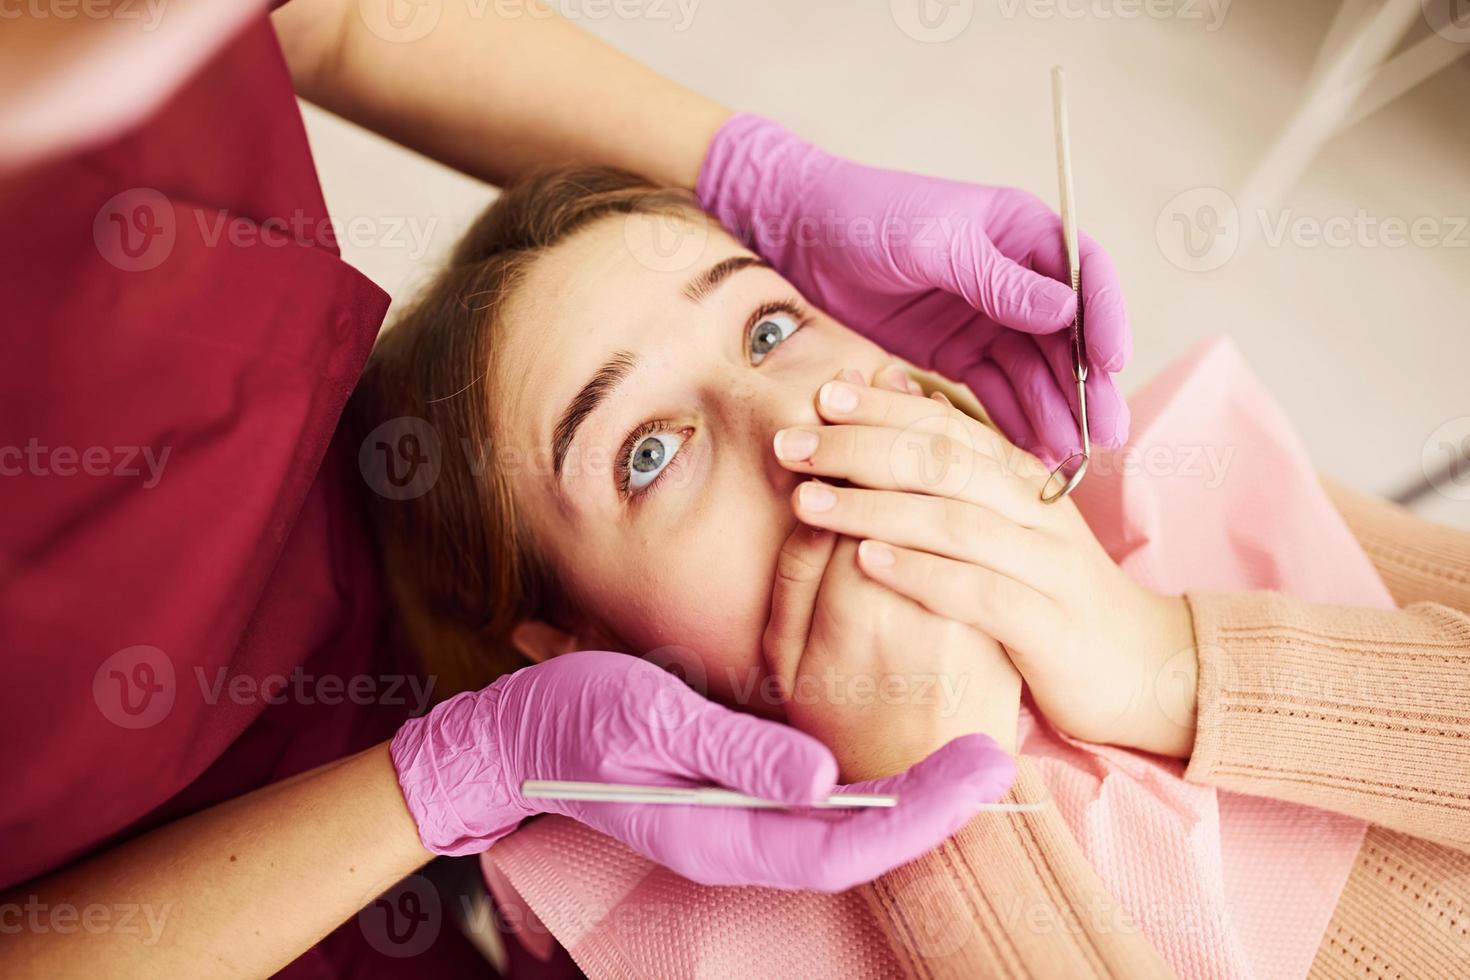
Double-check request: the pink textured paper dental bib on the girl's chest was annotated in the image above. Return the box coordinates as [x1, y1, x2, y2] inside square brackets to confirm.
[482, 339, 1392, 979]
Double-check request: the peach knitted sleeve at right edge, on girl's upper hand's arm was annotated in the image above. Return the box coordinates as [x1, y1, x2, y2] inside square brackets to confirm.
[1185, 486, 1470, 849]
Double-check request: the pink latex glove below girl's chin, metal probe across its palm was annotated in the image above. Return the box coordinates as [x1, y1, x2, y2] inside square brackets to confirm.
[391, 652, 1016, 892]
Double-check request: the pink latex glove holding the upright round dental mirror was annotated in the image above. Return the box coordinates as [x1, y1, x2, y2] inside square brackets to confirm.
[695, 115, 1132, 464]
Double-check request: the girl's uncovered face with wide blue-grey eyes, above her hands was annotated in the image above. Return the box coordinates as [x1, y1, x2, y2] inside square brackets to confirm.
[491, 215, 889, 714]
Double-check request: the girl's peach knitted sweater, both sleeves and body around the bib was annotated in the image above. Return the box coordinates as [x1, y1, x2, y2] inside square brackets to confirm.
[860, 486, 1470, 977]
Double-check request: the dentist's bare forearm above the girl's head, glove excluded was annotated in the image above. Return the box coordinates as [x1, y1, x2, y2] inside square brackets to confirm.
[272, 0, 729, 187]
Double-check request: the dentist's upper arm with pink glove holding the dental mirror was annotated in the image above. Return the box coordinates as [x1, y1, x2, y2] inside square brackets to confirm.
[273, 0, 1130, 461]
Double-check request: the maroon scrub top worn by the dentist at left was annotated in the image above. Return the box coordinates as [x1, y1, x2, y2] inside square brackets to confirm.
[0, 9, 492, 977]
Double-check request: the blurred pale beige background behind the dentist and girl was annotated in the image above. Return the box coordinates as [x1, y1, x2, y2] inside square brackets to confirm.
[306, 0, 1470, 526]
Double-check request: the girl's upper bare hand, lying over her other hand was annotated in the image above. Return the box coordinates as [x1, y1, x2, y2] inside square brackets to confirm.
[776, 367, 1195, 755]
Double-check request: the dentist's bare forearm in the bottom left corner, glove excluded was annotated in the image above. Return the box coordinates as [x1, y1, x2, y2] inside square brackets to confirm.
[0, 743, 432, 977]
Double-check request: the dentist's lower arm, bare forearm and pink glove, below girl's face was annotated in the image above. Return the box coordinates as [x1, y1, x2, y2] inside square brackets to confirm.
[0, 652, 1008, 977]
